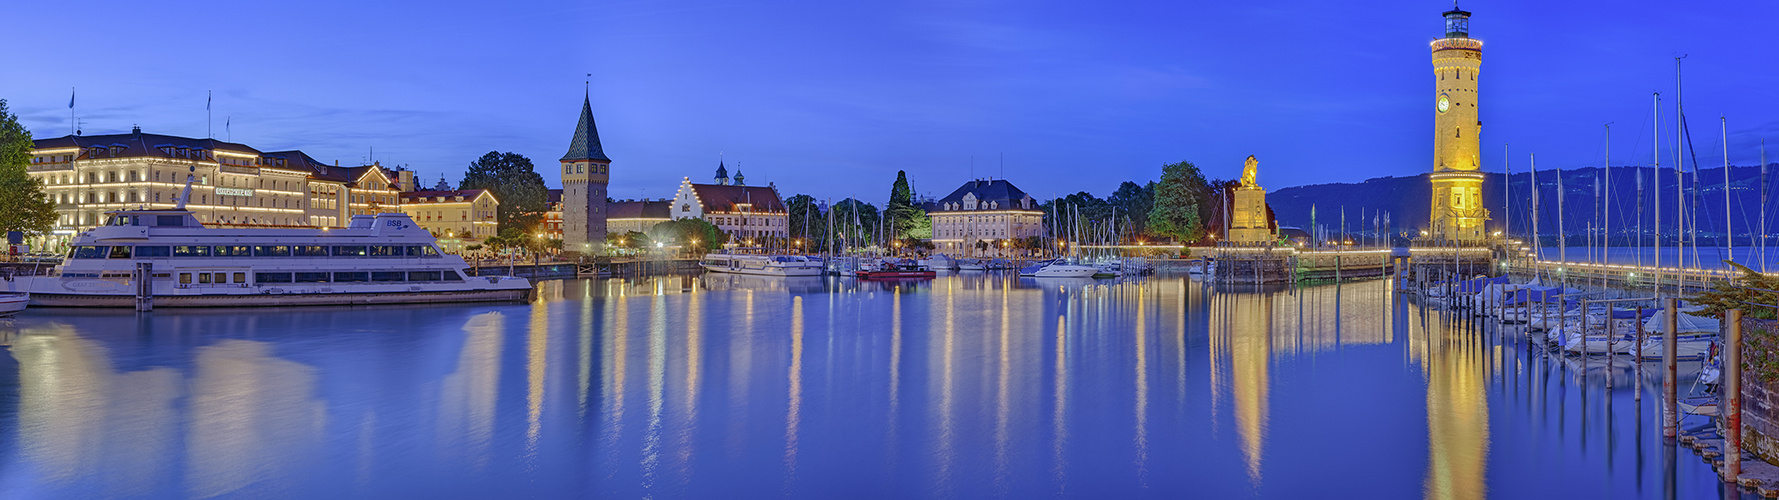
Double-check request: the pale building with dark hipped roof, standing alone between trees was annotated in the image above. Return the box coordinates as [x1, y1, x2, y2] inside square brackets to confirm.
[927, 180, 1044, 254]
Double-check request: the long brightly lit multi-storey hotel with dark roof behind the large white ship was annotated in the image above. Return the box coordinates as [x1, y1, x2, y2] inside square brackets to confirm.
[27, 128, 444, 251]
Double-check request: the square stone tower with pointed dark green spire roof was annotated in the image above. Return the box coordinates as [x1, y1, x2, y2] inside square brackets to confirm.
[562, 94, 612, 254]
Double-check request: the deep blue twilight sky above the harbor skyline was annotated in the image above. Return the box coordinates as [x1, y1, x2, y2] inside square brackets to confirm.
[0, 0, 1779, 201]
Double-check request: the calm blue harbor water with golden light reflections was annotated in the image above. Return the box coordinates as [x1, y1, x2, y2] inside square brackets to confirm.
[0, 274, 1733, 498]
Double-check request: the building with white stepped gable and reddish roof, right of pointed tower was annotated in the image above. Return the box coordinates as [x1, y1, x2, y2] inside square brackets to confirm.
[669, 165, 790, 246]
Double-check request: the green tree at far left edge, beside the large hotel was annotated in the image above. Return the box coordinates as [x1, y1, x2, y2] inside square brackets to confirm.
[0, 100, 57, 235]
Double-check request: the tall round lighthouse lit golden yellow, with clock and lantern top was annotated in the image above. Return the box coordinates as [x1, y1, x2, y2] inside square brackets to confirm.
[1429, 7, 1489, 244]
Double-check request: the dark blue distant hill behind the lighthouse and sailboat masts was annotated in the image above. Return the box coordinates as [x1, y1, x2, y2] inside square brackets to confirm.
[1267, 164, 1779, 244]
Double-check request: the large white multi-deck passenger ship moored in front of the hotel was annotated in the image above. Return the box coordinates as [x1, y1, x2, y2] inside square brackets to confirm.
[0, 203, 532, 308]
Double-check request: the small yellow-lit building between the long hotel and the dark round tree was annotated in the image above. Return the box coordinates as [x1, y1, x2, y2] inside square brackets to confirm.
[400, 189, 500, 251]
